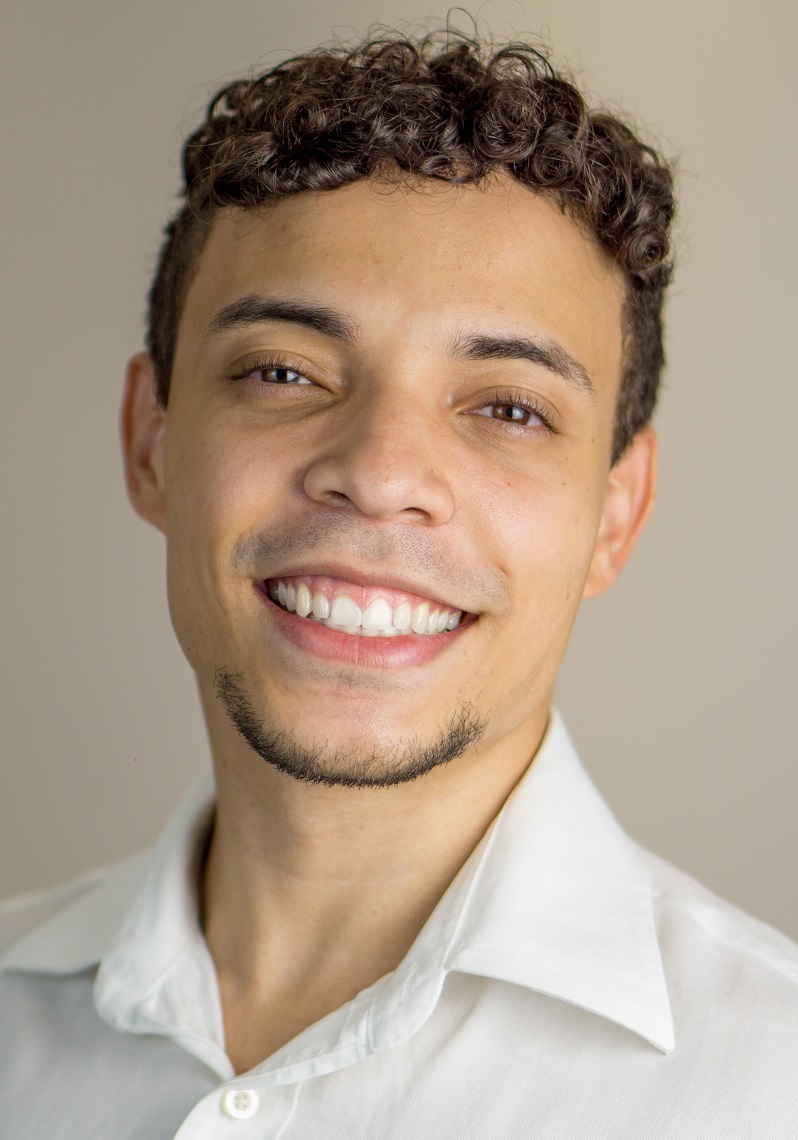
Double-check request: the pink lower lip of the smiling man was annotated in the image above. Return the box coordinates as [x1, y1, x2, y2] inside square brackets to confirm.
[255, 581, 473, 669]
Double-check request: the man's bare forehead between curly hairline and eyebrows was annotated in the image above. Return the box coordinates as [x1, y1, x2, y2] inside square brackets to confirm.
[177, 177, 625, 392]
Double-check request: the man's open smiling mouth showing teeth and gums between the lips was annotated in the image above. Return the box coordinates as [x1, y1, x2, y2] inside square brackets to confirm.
[262, 576, 466, 637]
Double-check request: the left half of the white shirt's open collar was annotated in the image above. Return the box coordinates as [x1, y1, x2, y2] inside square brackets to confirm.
[0, 770, 231, 1078]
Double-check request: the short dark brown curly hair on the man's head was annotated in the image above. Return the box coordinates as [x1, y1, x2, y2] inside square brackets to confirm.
[147, 32, 674, 463]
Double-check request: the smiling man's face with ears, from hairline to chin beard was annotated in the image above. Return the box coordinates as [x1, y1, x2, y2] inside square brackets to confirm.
[125, 173, 651, 783]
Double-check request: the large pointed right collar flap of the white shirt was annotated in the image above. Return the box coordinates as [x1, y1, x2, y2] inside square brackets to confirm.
[447, 714, 674, 1052]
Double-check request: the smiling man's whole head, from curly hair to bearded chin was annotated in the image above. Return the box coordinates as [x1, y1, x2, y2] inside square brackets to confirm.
[124, 36, 673, 783]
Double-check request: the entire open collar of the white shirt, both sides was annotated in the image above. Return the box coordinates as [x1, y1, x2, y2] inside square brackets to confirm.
[0, 713, 674, 1057]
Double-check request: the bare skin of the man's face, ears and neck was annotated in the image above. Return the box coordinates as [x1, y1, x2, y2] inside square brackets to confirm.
[122, 178, 656, 1072]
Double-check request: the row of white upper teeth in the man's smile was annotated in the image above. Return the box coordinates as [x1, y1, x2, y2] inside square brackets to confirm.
[269, 580, 463, 637]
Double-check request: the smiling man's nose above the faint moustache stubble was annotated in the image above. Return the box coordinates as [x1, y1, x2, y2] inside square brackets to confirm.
[304, 387, 455, 526]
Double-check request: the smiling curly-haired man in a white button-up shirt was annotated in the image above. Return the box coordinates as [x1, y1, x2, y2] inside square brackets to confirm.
[0, 26, 798, 1140]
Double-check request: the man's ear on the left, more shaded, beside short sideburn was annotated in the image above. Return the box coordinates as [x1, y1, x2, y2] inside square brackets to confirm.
[120, 352, 166, 534]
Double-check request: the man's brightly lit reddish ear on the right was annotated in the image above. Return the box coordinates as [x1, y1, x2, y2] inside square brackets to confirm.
[583, 428, 657, 597]
